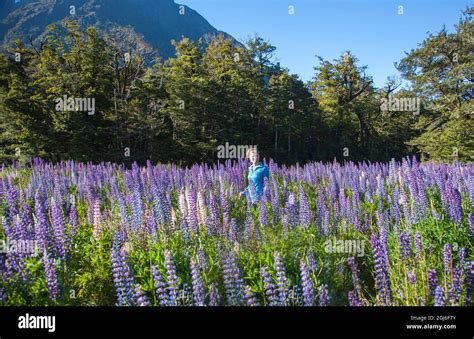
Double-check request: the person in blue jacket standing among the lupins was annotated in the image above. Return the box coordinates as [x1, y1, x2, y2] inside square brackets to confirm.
[240, 148, 270, 204]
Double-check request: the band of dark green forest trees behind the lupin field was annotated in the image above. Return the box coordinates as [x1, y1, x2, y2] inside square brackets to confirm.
[0, 7, 474, 165]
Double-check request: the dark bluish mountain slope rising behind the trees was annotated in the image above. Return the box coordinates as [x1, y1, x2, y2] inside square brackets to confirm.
[0, 0, 237, 59]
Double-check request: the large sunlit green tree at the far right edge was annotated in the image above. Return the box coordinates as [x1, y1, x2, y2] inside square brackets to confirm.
[398, 7, 474, 161]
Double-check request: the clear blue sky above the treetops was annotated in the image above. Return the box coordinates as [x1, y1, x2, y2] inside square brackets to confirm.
[176, 0, 473, 87]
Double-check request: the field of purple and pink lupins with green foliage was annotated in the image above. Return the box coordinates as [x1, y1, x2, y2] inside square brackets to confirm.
[0, 159, 474, 306]
